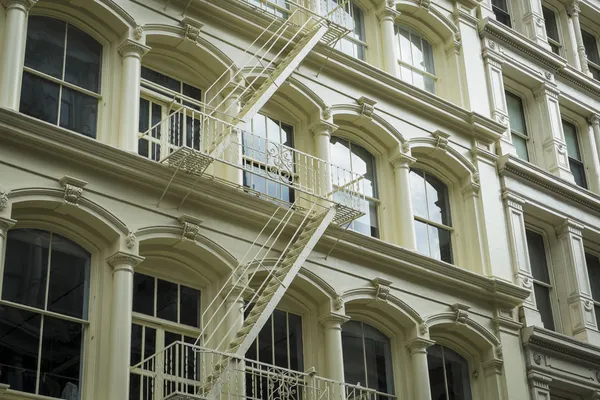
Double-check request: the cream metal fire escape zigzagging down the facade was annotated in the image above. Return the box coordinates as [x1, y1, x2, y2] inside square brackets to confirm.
[131, 0, 373, 400]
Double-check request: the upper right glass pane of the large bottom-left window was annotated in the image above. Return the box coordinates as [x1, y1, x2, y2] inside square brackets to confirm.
[48, 234, 90, 319]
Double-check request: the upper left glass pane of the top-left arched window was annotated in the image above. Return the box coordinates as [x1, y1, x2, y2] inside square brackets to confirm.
[25, 16, 66, 79]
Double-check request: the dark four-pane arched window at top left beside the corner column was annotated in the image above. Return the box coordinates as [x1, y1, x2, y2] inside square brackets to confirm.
[19, 16, 102, 138]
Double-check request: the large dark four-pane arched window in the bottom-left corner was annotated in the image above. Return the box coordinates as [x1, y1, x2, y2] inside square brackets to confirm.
[0, 229, 91, 399]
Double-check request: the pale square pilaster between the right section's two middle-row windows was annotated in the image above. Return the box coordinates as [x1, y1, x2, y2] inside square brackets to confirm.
[533, 83, 575, 182]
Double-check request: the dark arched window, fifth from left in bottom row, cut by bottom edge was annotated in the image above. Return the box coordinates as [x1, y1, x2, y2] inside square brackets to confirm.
[427, 344, 472, 400]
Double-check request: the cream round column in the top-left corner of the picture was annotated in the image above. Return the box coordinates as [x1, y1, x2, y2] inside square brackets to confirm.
[0, 0, 37, 111]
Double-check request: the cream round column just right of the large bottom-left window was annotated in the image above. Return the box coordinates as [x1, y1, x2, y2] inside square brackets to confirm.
[106, 251, 144, 399]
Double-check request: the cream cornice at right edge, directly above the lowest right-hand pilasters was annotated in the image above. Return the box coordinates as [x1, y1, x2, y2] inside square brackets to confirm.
[498, 155, 600, 213]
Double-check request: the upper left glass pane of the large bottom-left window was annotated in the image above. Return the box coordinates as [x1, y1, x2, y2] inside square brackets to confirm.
[2, 229, 50, 309]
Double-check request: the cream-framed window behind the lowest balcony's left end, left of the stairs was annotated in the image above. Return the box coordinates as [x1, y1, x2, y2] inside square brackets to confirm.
[129, 273, 200, 400]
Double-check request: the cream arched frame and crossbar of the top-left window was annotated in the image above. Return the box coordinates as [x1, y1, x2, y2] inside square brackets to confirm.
[19, 11, 110, 142]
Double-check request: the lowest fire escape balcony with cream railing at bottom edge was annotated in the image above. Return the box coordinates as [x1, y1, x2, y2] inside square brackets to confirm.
[131, 342, 395, 400]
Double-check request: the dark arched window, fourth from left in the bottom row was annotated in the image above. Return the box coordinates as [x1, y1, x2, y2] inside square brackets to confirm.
[342, 321, 394, 399]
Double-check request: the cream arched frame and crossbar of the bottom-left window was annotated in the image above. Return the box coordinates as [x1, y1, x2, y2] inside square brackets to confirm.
[0, 227, 94, 398]
